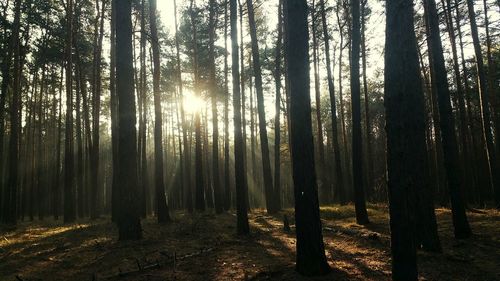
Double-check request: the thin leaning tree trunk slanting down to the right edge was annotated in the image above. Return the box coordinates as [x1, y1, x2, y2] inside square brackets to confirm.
[466, 0, 500, 208]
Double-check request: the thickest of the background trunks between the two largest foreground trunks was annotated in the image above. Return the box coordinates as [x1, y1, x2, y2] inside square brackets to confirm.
[351, 0, 369, 225]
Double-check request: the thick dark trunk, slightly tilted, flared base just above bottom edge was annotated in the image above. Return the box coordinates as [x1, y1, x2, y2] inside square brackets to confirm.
[286, 0, 330, 276]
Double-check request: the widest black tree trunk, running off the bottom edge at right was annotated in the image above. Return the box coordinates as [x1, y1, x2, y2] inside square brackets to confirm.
[385, 0, 427, 276]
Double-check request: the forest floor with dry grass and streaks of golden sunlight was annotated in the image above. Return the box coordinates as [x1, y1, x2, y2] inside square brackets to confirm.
[0, 205, 500, 281]
